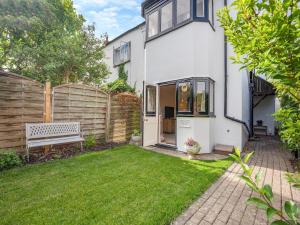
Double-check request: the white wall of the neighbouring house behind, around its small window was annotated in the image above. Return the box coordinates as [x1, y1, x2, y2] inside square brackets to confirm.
[104, 25, 145, 94]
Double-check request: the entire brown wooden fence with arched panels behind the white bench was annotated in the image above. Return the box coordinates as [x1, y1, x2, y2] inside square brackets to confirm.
[0, 71, 141, 153]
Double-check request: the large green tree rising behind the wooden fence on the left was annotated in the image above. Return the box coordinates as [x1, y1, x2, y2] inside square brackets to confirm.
[0, 0, 108, 85]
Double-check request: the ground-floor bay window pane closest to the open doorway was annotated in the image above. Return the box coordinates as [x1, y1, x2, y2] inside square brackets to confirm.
[177, 82, 192, 112]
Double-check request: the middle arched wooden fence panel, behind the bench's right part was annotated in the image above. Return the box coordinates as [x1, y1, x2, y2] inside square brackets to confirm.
[52, 84, 108, 141]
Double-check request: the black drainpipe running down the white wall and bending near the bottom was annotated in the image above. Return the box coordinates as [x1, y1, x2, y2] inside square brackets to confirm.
[224, 0, 251, 139]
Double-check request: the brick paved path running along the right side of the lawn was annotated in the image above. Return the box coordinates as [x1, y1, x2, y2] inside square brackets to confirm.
[172, 138, 300, 225]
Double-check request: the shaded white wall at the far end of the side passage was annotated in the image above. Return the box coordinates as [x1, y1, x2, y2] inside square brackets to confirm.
[253, 95, 275, 135]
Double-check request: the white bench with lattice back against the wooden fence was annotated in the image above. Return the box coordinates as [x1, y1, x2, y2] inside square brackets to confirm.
[26, 123, 84, 160]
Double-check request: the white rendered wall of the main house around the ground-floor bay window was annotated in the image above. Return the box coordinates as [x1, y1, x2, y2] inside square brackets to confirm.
[145, 1, 249, 152]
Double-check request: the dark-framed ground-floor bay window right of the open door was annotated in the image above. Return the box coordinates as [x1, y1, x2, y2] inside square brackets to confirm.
[176, 78, 214, 116]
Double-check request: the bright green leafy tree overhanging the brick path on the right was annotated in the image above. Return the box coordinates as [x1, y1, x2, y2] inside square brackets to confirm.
[218, 0, 300, 149]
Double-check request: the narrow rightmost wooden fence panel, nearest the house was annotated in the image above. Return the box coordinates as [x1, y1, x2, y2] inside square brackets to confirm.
[109, 93, 141, 143]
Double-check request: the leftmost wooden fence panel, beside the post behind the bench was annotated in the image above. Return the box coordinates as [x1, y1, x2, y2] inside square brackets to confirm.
[0, 71, 44, 149]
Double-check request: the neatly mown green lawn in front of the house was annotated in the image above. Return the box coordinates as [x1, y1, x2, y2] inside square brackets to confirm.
[0, 145, 231, 225]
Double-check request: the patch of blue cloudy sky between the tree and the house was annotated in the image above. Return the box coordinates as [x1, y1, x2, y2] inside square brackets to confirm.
[73, 0, 143, 40]
